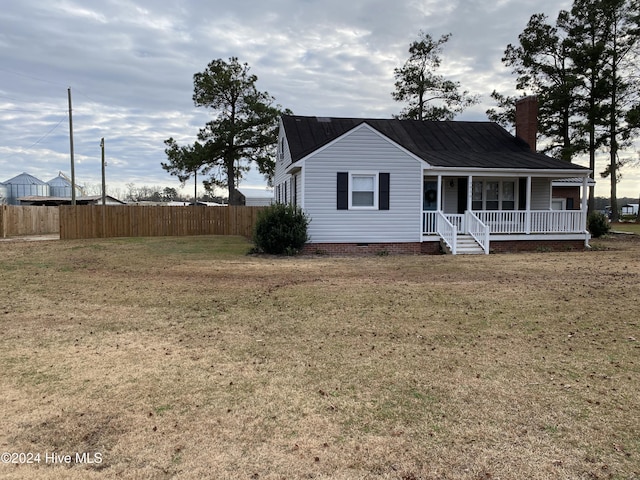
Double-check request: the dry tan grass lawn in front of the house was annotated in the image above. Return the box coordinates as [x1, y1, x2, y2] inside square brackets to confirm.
[0, 236, 640, 480]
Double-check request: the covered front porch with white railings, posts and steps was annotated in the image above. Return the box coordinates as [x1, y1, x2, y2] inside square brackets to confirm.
[422, 171, 590, 254]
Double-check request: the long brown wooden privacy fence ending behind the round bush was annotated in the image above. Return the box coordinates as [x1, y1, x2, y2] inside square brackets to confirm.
[60, 205, 264, 240]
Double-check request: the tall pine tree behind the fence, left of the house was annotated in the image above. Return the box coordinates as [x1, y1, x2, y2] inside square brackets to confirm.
[162, 57, 288, 205]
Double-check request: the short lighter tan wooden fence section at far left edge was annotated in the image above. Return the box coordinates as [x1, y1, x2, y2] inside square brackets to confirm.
[0, 205, 60, 238]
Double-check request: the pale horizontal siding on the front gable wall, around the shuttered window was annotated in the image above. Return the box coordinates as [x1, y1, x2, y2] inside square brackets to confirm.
[300, 125, 422, 243]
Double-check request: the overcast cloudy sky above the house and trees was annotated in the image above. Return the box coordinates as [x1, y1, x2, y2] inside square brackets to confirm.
[0, 0, 640, 197]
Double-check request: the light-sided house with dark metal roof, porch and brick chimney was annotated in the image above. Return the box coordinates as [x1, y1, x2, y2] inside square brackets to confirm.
[274, 98, 590, 253]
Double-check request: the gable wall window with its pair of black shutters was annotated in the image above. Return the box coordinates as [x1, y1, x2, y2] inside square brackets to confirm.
[336, 172, 390, 210]
